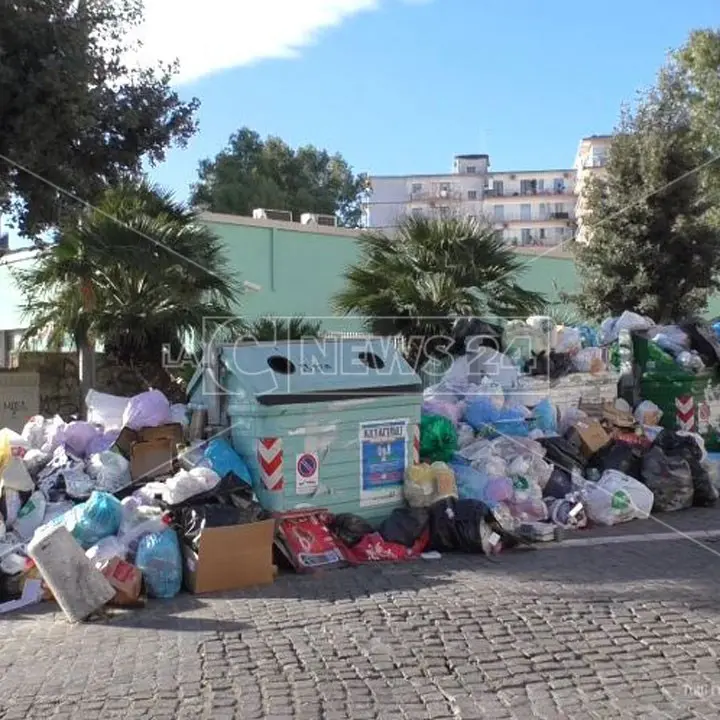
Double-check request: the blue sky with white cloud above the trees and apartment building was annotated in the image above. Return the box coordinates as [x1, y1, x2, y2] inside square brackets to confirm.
[5, 0, 720, 245]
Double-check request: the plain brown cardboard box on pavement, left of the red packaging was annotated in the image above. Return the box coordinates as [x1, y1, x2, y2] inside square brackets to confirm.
[183, 519, 275, 594]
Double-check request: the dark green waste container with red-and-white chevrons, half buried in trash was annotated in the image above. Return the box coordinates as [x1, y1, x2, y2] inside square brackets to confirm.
[632, 333, 720, 450]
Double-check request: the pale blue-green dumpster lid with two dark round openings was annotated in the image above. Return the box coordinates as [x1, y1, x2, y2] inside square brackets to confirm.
[211, 338, 422, 405]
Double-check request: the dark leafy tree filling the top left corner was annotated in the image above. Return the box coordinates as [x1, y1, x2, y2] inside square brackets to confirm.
[0, 0, 198, 235]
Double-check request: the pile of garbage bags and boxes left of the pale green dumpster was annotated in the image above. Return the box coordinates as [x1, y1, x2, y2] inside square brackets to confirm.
[0, 390, 274, 621]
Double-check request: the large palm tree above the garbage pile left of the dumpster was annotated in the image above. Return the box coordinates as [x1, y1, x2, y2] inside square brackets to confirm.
[17, 182, 240, 396]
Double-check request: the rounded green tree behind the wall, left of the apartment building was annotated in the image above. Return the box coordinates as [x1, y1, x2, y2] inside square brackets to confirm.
[192, 128, 367, 227]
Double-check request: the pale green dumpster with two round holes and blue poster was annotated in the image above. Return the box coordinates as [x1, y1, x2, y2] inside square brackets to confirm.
[190, 338, 422, 520]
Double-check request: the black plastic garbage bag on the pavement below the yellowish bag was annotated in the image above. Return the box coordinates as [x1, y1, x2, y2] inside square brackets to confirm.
[428, 498, 519, 555]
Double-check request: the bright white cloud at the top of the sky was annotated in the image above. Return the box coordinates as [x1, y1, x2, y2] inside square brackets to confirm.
[131, 0, 388, 82]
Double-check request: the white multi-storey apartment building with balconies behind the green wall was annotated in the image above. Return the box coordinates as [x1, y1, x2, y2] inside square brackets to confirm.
[364, 135, 610, 247]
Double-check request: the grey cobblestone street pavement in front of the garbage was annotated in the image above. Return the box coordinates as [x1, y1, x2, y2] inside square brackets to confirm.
[0, 509, 720, 720]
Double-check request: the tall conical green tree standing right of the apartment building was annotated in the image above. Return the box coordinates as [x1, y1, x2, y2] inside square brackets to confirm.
[574, 33, 720, 322]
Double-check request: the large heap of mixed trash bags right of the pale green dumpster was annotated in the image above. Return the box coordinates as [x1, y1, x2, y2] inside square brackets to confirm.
[405, 312, 720, 541]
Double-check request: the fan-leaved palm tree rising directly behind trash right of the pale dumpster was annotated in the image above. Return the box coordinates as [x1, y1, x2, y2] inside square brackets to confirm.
[334, 217, 543, 367]
